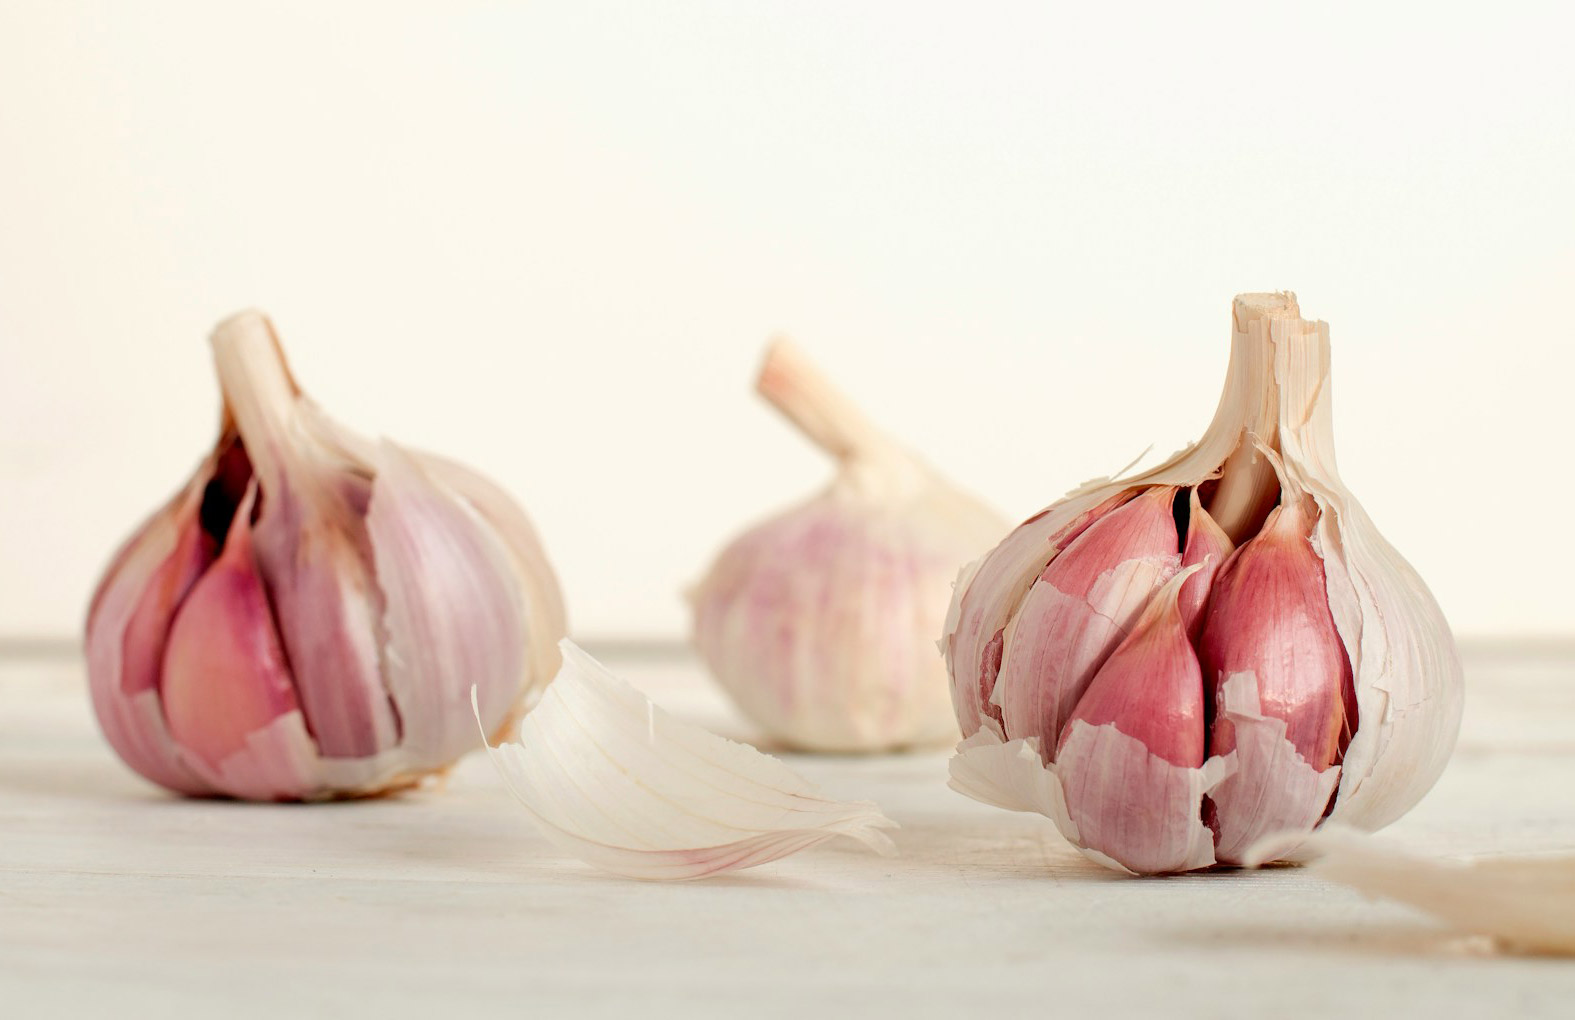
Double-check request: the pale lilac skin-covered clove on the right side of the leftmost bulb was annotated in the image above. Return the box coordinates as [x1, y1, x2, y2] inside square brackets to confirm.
[367, 441, 528, 770]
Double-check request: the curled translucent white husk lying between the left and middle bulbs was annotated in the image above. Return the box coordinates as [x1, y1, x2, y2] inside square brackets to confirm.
[484, 639, 896, 880]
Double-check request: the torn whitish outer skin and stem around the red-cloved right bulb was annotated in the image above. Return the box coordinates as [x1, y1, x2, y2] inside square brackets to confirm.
[942, 294, 1462, 875]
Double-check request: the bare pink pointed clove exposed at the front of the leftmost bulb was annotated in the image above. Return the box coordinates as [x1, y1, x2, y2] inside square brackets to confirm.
[159, 483, 309, 783]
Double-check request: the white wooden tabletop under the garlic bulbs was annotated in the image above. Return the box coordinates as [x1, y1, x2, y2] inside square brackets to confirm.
[0, 645, 1575, 1018]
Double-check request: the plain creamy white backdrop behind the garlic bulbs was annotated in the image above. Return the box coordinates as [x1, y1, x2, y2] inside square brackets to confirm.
[0, 2, 1575, 638]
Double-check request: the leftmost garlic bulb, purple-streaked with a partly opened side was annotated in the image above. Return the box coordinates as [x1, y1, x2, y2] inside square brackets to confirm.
[87, 312, 564, 800]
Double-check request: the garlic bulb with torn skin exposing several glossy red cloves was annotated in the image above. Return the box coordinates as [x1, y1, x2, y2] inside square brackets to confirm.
[942, 294, 1462, 872]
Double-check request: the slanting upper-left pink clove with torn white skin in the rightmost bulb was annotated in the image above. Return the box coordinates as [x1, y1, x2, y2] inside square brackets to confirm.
[991, 486, 1181, 751]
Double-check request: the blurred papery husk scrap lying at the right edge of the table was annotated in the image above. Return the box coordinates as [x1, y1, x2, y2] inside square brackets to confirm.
[1247, 825, 1575, 955]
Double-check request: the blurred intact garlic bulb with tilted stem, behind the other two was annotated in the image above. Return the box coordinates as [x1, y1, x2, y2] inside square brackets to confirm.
[690, 340, 1006, 751]
